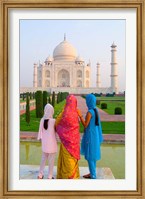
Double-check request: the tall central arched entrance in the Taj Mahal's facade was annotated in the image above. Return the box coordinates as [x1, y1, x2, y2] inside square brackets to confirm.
[57, 69, 70, 87]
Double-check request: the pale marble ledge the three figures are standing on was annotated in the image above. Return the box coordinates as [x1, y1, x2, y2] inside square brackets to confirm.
[20, 165, 115, 180]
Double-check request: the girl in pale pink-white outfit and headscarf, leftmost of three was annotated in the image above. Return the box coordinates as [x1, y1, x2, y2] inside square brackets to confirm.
[37, 104, 57, 179]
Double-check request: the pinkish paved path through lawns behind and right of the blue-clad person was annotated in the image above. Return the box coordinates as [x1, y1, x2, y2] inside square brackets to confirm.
[76, 96, 125, 122]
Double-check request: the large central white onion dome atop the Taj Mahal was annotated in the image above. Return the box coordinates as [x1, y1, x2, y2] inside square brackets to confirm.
[53, 38, 77, 60]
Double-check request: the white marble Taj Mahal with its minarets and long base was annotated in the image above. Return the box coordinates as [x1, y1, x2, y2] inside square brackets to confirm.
[20, 35, 118, 94]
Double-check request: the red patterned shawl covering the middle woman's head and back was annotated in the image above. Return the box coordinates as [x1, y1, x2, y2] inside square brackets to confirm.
[56, 95, 80, 159]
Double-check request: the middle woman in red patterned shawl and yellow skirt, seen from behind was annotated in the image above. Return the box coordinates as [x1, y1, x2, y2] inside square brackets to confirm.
[56, 95, 80, 179]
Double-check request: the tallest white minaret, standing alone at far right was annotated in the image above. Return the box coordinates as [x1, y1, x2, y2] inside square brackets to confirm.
[110, 42, 118, 94]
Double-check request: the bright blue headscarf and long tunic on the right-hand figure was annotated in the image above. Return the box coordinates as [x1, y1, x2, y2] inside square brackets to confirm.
[81, 94, 103, 161]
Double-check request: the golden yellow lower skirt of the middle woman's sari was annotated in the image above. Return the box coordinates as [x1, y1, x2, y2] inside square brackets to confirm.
[57, 143, 80, 179]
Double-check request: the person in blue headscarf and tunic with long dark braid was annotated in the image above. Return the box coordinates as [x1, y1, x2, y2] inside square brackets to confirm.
[78, 94, 103, 179]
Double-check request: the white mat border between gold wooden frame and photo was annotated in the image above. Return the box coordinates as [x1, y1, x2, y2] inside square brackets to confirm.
[8, 8, 137, 191]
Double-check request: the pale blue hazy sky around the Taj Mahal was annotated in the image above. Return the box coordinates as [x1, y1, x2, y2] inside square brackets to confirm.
[20, 20, 125, 91]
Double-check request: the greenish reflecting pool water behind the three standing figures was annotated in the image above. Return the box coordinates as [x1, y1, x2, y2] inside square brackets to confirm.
[20, 141, 125, 179]
